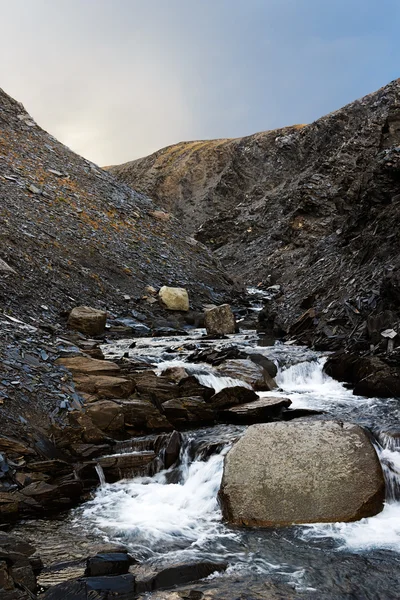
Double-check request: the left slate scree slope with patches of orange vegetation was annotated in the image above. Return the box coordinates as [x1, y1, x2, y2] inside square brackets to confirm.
[0, 90, 231, 442]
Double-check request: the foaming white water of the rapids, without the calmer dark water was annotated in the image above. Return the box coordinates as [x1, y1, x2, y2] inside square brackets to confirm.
[77, 358, 400, 583]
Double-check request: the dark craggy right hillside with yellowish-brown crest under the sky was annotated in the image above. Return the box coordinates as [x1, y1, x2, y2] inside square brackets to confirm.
[110, 79, 400, 345]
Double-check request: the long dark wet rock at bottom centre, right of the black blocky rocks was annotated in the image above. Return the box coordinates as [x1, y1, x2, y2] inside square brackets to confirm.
[131, 561, 228, 594]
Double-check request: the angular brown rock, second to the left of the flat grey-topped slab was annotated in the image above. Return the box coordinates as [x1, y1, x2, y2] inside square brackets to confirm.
[119, 398, 172, 432]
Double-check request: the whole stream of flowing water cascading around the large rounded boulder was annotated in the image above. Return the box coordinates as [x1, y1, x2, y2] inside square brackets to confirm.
[14, 331, 400, 600]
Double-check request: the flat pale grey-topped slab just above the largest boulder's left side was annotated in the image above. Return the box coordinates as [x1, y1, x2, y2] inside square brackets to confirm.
[218, 398, 292, 425]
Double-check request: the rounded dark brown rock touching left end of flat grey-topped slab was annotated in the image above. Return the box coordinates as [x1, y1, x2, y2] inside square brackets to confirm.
[162, 396, 215, 428]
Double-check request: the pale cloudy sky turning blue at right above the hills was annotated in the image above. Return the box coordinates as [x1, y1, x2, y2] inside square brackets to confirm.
[0, 0, 400, 166]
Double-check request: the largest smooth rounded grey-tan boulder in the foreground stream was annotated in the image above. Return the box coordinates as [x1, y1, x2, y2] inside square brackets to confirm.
[220, 420, 385, 527]
